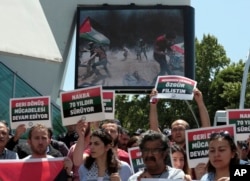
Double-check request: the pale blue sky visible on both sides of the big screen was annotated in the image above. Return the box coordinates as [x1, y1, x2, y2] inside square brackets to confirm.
[63, 0, 250, 91]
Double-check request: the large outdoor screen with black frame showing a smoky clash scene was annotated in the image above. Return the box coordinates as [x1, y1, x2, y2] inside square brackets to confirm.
[75, 5, 194, 93]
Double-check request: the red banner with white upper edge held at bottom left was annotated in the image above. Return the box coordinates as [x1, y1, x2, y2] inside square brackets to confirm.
[0, 157, 64, 181]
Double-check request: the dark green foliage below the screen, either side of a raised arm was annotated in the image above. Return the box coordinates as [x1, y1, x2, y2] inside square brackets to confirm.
[115, 94, 201, 133]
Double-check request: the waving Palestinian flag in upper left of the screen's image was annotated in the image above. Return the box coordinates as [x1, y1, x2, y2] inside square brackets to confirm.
[79, 17, 110, 45]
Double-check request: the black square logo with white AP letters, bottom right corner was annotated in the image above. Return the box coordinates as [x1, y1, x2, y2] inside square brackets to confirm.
[230, 165, 250, 181]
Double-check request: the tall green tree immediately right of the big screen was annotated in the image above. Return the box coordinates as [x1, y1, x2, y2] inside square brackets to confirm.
[194, 34, 230, 123]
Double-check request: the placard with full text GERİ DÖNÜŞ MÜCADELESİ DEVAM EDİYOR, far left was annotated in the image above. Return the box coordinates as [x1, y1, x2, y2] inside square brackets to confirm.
[11, 97, 49, 122]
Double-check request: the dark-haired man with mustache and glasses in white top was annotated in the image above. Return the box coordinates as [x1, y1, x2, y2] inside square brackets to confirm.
[128, 130, 185, 181]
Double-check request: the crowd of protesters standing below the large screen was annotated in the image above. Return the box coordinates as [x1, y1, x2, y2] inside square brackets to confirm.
[0, 89, 250, 181]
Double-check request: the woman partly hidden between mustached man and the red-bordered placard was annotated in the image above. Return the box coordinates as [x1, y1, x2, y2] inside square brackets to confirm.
[170, 144, 192, 181]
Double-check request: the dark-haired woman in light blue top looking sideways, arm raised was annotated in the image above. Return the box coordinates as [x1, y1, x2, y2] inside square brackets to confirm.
[73, 121, 132, 181]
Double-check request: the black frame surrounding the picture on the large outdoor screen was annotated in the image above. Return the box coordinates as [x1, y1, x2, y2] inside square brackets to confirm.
[75, 5, 195, 94]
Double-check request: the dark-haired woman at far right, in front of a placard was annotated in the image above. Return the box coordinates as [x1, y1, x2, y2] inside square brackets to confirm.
[201, 131, 240, 181]
